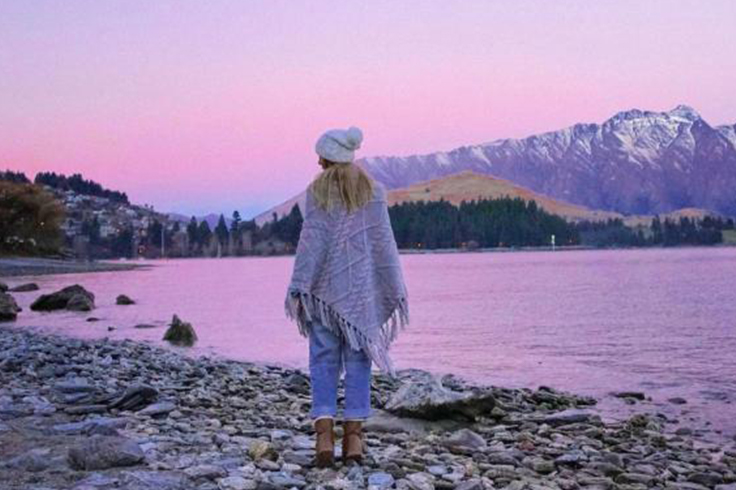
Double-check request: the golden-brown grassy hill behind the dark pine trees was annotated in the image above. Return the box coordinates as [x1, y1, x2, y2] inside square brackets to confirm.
[388, 170, 623, 221]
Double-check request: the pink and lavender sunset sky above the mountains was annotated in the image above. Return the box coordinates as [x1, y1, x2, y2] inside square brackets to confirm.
[0, 0, 736, 217]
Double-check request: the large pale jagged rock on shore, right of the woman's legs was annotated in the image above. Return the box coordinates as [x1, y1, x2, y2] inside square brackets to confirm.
[384, 377, 496, 421]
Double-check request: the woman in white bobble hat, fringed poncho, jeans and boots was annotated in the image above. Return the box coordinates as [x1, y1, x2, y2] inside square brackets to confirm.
[285, 127, 409, 467]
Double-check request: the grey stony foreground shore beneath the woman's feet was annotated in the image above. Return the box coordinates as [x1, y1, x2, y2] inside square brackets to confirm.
[0, 327, 736, 490]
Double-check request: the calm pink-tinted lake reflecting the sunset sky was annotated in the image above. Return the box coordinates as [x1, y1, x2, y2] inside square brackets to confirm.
[8, 248, 736, 437]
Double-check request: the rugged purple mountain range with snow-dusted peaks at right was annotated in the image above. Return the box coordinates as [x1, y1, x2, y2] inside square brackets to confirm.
[358, 105, 736, 216]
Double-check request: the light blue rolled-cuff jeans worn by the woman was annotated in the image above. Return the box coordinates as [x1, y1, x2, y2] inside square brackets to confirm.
[309, 322, 371, 420]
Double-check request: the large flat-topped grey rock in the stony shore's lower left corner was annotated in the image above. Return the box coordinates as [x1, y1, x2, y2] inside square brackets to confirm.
[68, 436, 145, 471]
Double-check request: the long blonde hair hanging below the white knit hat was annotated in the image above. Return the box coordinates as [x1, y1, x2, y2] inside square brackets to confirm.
[310, 158, 373, 213]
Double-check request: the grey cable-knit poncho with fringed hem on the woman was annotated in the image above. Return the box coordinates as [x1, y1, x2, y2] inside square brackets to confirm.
[285, 183, 409, 375]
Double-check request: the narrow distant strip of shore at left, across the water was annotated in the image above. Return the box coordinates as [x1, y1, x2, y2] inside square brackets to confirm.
[0, 257, 150, 277]
